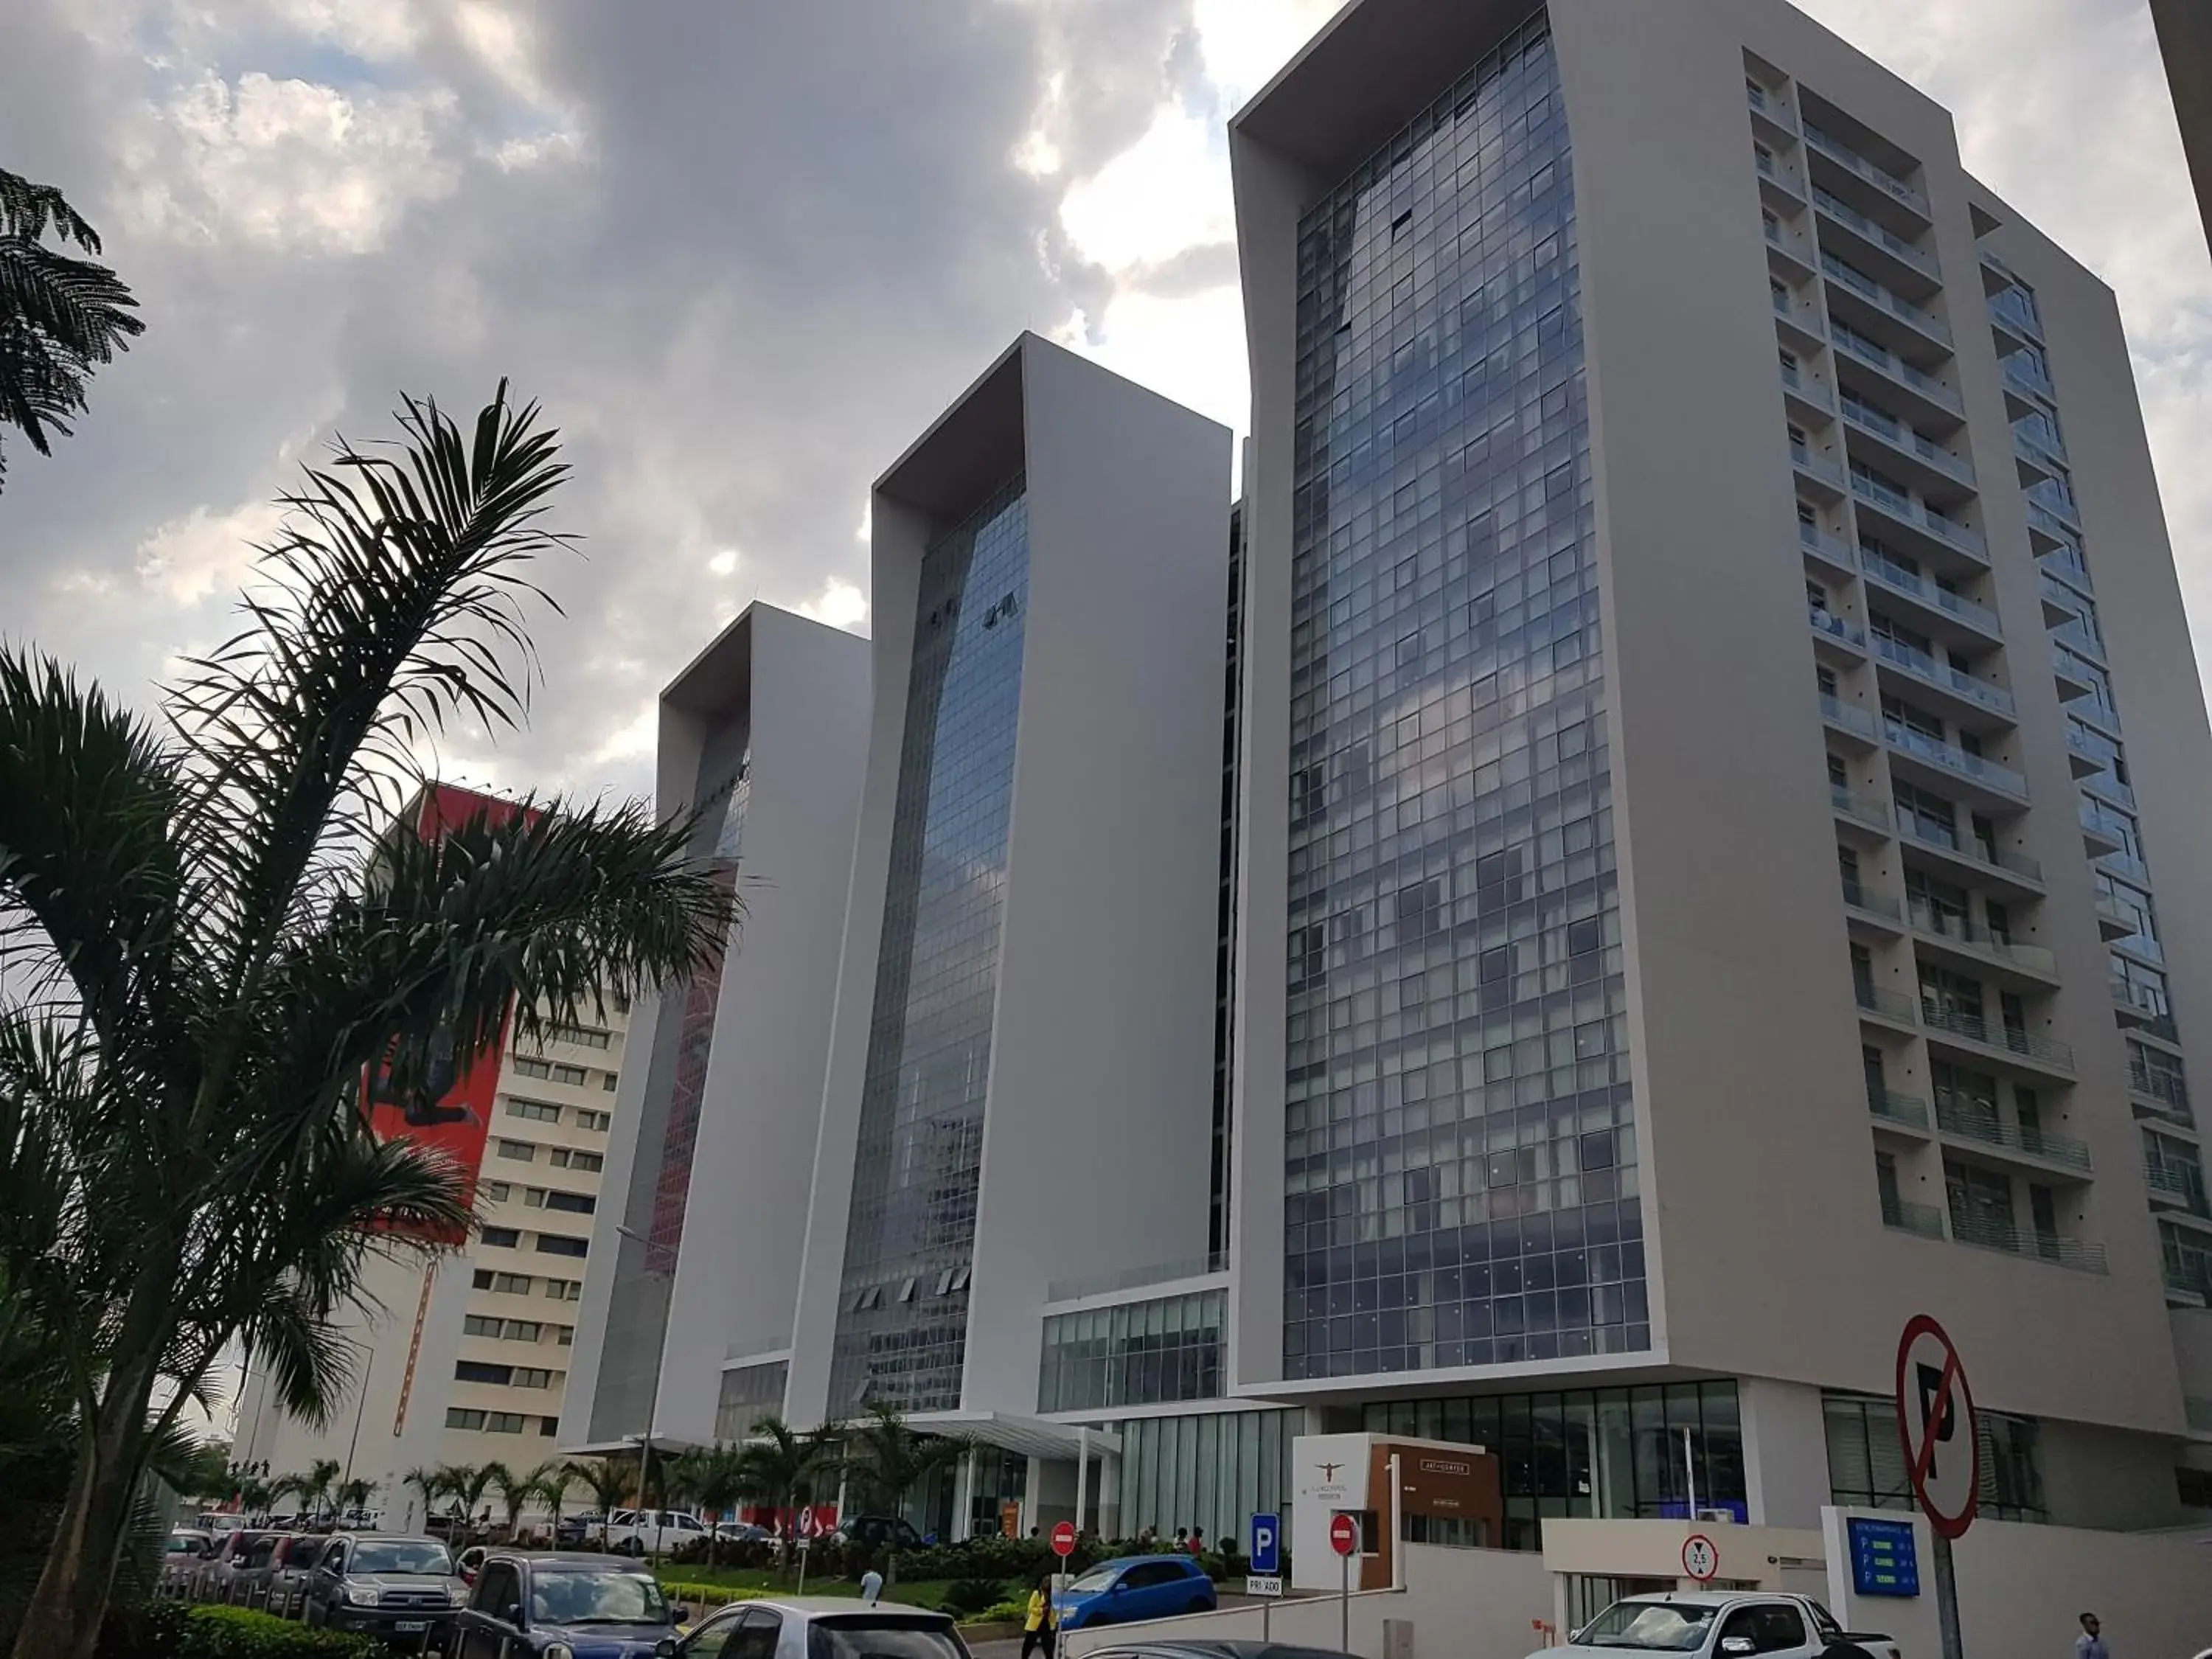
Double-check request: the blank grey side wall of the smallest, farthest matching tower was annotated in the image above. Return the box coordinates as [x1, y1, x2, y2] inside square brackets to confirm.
[657, 606, 869, 1440]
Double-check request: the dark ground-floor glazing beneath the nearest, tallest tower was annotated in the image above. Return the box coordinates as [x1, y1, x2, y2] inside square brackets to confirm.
[1360, 1380, 1750, 1551]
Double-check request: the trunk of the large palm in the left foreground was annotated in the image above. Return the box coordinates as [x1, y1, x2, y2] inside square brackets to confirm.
[15, 1349, 155, 1659]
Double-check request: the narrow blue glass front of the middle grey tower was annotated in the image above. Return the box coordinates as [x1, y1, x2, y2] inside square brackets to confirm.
[830, 478, 1029, 1416]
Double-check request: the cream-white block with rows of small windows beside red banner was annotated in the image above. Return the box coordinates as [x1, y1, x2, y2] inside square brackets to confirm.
[234, 998, 630, 1531]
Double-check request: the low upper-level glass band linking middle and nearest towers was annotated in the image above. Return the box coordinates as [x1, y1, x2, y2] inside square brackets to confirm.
[1037, 1290, 1228, 1411]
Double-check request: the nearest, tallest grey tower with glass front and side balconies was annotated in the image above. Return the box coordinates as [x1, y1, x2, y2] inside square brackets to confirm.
[1221, 0, 2212, 1546]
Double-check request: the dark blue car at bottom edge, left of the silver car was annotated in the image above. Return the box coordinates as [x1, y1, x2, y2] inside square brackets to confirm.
[447, 1551, 677, 1659]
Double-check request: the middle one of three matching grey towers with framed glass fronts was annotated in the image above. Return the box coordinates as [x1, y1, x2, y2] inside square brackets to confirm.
[785, 334, 1230, 1469]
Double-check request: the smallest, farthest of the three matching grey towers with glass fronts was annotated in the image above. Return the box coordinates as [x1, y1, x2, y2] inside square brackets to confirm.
[562, 604, 869, 1449]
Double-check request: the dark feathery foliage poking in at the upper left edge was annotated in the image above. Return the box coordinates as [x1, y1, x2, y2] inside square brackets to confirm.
[0, 168, 146, 484]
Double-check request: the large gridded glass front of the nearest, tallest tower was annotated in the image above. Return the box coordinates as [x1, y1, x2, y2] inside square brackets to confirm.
[1283, 13, 1650, 1378]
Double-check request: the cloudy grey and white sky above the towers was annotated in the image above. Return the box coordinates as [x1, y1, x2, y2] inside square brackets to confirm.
[0, 0, 2212, 818]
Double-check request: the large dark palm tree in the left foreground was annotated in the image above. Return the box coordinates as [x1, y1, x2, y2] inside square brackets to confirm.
[0, 385, 734, 1659]
